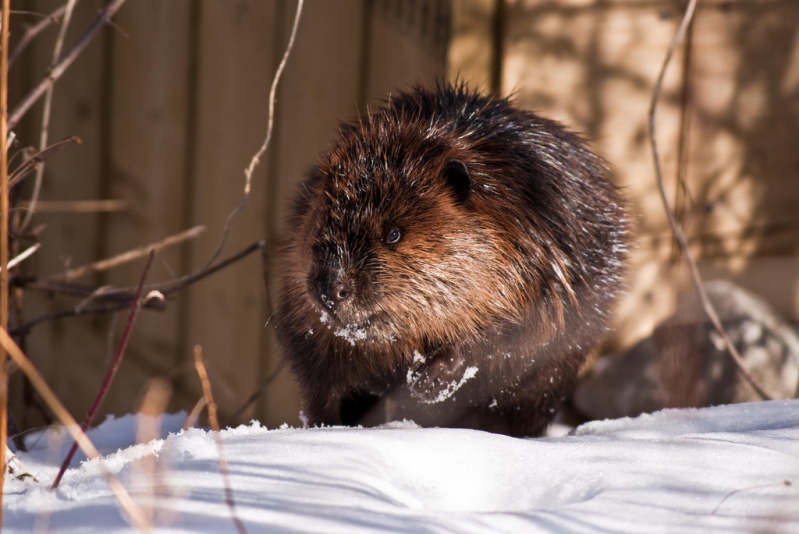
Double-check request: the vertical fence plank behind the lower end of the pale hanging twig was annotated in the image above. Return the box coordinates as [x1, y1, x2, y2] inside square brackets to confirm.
[181, 0, 278, 428]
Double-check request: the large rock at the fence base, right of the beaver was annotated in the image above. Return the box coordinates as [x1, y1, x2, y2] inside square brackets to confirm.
[574, 280, 799, 419]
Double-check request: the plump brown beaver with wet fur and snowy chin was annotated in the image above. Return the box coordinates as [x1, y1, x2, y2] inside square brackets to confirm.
[275, 83, 628, 436]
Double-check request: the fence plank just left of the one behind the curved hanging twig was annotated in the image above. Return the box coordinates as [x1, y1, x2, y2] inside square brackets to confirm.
[100, 0, 196, 413]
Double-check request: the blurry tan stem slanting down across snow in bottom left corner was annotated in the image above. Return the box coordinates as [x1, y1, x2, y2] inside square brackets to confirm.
[0, 328, 152, 532]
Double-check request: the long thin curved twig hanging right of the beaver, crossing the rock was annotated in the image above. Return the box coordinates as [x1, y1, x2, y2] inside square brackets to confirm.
[649, 0, 771, 400]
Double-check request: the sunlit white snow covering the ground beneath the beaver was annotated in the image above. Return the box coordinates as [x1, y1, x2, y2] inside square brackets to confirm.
[4, 400, 799, 533]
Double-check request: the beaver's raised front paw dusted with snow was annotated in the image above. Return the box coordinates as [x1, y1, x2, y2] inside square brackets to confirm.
[406, 352, 477, 404]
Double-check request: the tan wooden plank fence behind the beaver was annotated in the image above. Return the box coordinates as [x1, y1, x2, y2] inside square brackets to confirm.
[11, 0, 799, 434]
